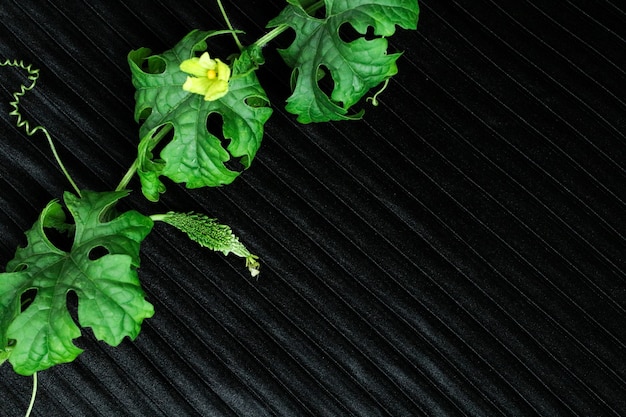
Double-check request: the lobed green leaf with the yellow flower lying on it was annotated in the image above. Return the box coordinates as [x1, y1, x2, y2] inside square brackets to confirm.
[128, 30, 272, 201]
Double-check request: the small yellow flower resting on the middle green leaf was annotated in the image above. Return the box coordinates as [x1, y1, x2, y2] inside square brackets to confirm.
[180, 52, 230, 101]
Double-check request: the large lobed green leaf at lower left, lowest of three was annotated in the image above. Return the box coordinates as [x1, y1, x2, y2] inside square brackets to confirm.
[0, 191, 154, 375]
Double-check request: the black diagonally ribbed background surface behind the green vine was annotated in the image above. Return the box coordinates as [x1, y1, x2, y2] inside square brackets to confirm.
[0, 0, 626, 417]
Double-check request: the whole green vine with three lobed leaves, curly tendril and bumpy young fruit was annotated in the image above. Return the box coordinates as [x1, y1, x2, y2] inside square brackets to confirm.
[0, 0, 419, 375]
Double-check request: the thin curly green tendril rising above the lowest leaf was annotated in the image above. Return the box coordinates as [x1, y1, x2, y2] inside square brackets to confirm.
[0, 59, 81, 196]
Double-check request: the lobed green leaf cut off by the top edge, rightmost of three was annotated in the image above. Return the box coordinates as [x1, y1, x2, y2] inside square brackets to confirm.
[268, 0, 419, 123]
